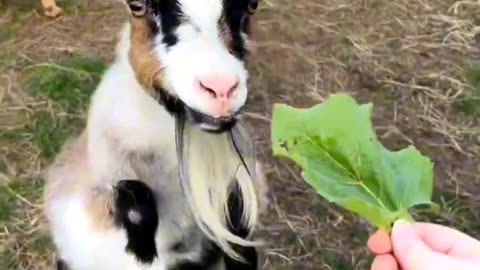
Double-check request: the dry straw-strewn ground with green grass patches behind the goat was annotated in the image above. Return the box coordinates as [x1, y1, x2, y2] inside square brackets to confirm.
[0, 0, 480, 270]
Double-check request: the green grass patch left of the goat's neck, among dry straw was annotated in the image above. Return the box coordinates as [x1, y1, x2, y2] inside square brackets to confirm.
[0, 56, 107, 160]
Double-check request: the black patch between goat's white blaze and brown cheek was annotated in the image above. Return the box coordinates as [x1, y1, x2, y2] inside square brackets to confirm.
[147, 0, 183, 48]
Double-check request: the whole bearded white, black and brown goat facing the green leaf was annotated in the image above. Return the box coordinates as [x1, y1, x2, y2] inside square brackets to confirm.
[45, 0, 266, 270]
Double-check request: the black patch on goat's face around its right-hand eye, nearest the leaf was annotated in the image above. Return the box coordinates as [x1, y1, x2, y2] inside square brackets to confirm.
[223, 0, 250, 60]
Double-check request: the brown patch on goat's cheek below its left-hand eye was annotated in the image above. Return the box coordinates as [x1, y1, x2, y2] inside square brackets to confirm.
[129, 17, 163, 91]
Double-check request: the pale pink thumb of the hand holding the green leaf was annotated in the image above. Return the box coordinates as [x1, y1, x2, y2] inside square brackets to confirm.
[392, 220, 474, 270]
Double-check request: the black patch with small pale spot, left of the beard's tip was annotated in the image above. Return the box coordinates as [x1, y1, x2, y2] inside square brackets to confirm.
[114, 180, 158, 264]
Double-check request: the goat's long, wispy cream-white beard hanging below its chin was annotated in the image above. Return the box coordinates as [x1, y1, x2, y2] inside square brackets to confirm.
[176, 115, 258, 260]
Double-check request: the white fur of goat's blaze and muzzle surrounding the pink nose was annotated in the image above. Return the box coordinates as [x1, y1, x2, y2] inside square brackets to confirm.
[155, 0, 248, 118]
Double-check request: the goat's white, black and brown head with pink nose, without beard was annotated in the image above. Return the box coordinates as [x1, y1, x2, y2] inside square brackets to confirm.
[126, 0, 258, 132]
